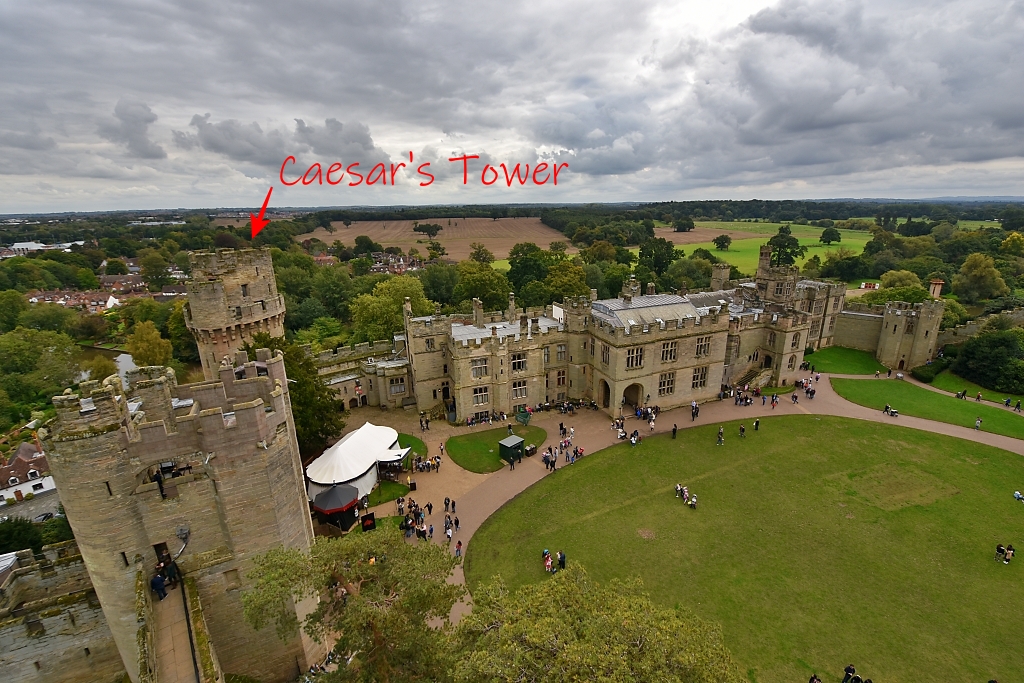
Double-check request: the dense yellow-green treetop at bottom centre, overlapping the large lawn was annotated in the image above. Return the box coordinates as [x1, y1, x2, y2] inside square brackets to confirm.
[453, 565, 741, 683]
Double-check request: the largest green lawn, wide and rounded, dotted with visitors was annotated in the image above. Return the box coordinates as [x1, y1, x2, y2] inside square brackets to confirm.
[465, 417, 1024, 683]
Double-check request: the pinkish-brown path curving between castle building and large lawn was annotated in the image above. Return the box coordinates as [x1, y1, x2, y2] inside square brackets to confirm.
[349, 373, 1024, 622]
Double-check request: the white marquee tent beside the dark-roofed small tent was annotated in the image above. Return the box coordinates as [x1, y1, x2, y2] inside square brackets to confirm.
[306, 422, 410, 501]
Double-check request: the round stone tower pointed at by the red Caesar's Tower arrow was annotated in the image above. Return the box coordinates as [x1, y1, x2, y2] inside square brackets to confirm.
[185, 249, 285, 380]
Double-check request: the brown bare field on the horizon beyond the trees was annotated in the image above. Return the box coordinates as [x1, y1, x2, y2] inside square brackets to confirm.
[295, 218, 577, 261]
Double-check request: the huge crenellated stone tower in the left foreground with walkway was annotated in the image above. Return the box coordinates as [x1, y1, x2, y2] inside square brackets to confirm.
[44, 349, 324, 682]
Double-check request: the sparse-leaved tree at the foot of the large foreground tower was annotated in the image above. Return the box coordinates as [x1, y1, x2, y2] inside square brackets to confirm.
[242, 526, 465, 683]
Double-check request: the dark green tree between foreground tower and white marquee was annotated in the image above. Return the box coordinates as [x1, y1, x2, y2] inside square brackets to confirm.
[242, 332, 345, 461]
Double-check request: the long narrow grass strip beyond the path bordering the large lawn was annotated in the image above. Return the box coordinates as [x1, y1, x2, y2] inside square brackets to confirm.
[831, 379, 1024, 438]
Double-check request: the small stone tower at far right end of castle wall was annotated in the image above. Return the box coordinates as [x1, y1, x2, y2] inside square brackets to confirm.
[874, 299, 945, 370]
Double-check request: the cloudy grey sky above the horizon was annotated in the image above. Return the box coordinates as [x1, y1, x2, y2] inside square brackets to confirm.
[0, 0, 1024, 213]
